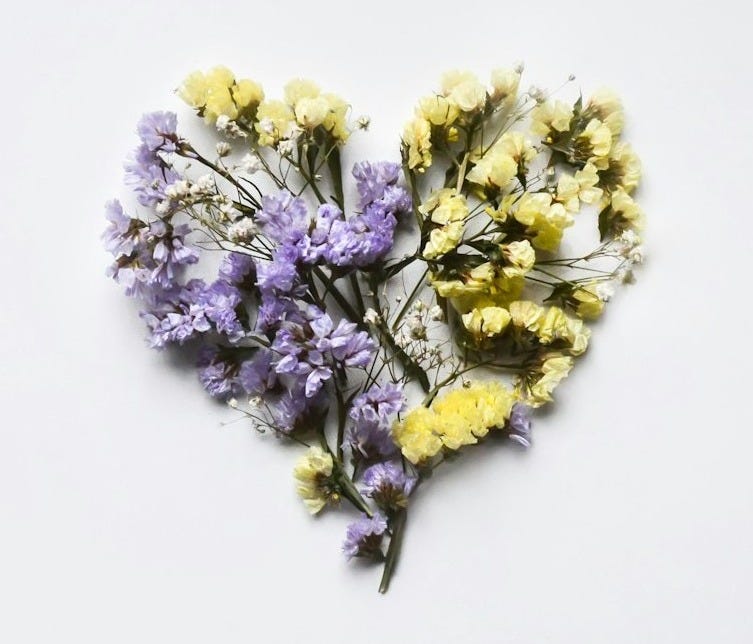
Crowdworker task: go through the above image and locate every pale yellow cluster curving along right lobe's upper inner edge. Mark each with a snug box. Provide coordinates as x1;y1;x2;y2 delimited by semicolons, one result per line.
402;69;520;172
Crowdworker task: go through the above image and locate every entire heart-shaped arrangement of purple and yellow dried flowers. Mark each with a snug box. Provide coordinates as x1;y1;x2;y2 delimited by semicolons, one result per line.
104;67;643;592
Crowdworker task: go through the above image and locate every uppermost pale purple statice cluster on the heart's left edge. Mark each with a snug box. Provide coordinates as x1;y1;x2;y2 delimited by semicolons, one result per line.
125;112;181;209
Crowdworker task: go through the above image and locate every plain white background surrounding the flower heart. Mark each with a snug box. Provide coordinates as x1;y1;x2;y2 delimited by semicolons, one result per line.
0;0;753;644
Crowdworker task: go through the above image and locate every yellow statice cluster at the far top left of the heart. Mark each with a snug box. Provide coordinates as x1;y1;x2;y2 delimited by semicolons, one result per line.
178;66;264;123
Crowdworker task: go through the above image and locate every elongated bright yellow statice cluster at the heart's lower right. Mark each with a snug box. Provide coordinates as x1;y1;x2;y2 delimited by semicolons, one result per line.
392;381;516;465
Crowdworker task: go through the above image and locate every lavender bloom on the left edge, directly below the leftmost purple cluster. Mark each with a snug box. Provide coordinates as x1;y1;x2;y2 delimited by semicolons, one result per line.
140;280;212;349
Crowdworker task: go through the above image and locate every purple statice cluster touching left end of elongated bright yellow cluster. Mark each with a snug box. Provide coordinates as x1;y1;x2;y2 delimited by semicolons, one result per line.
345;383;405;462
